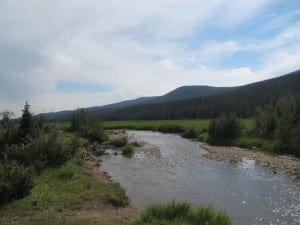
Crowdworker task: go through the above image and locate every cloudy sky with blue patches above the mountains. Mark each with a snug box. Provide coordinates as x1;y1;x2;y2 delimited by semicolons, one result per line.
0;0;300;115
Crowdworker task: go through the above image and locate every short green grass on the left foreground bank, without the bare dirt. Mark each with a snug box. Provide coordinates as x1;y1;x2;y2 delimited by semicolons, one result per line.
0;151;128;225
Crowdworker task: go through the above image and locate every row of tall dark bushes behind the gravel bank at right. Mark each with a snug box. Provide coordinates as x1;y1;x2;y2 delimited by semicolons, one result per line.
208;94;300;157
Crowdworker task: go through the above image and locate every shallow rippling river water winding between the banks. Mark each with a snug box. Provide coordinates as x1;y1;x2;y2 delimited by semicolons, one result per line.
101;131;300;225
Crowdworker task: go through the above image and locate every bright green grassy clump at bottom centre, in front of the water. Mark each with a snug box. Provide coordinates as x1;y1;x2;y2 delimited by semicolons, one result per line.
134;201;232;225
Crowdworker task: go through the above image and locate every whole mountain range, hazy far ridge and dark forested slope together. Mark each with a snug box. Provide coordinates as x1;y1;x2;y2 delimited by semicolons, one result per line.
44;70;300;120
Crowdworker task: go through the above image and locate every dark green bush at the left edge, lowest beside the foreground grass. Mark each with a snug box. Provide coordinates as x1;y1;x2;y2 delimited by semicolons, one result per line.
0;162;33;205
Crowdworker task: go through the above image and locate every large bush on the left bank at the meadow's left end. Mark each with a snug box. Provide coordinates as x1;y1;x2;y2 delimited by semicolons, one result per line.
70;109;107;142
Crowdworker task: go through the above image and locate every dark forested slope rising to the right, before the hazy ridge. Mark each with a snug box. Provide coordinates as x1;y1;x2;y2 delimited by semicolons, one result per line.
101;70;300;120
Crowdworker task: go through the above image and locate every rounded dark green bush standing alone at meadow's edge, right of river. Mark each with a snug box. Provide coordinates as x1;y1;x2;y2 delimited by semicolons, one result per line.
208;113;242;144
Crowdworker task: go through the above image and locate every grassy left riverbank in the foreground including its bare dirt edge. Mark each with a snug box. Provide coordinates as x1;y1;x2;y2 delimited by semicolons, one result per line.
0;148;138;225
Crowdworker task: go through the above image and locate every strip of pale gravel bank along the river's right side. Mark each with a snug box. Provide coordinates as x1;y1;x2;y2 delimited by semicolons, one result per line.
201;143;300;176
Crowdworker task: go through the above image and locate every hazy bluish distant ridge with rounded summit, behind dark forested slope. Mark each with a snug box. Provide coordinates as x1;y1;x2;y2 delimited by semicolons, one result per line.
42;86;234;121
